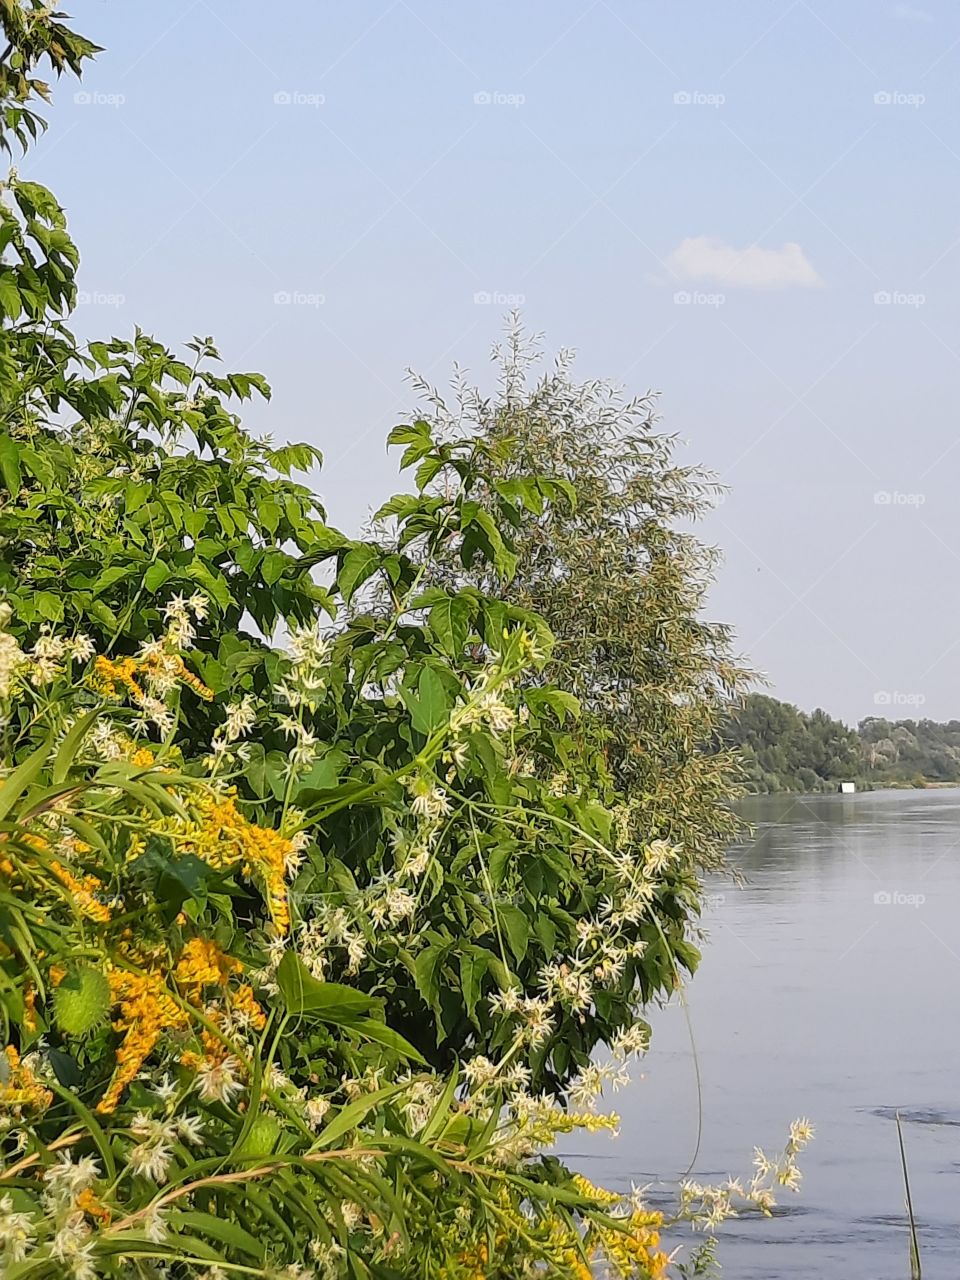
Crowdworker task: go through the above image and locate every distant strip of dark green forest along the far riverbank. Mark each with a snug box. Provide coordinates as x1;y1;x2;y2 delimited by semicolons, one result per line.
723;694;960;792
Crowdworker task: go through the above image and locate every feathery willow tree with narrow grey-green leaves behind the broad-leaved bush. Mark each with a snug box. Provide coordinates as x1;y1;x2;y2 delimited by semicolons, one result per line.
413;317;750;869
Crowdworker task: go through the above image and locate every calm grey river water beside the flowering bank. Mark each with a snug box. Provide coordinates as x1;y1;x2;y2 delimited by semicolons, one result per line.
566;788;960;1280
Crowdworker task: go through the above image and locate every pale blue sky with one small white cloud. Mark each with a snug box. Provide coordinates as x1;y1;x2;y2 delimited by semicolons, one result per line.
32;0;960;722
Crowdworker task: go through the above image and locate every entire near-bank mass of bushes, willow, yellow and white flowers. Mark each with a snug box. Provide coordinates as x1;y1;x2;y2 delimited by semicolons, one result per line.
0;0;810;1280
